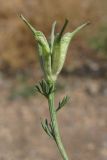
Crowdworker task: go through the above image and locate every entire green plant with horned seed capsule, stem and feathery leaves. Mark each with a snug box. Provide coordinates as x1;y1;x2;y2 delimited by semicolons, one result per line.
20;15;89;160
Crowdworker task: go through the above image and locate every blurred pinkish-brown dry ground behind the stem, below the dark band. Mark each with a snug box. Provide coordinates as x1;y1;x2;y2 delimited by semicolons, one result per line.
0;77;107;160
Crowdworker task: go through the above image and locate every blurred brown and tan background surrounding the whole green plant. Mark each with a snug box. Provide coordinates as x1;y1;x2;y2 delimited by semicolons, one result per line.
0;0;107;160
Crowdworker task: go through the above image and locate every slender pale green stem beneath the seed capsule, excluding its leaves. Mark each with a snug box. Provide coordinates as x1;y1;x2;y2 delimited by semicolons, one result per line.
48;83;68;160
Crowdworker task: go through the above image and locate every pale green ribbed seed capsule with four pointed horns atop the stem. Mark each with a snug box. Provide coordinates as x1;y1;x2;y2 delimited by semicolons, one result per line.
20;15;89;82
